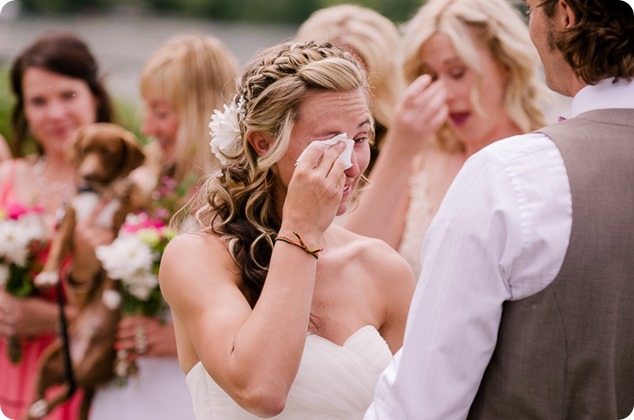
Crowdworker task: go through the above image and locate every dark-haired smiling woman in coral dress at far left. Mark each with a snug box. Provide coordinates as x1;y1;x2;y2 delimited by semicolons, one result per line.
0;32;113;420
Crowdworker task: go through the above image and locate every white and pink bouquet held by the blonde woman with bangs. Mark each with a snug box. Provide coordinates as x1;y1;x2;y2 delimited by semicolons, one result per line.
96;212;175;385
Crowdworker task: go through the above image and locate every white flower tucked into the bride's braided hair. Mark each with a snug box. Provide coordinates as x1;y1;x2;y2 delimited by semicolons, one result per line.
209;103;244;165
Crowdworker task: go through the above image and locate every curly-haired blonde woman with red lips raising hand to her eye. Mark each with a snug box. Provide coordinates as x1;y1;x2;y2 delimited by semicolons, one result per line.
346;0;549;277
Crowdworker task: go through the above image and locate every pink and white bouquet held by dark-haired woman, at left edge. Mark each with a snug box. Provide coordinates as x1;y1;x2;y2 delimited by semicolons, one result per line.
0;204;48;363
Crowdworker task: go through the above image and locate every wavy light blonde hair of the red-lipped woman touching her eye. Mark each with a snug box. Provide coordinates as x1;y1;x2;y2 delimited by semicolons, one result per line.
401;0;552;150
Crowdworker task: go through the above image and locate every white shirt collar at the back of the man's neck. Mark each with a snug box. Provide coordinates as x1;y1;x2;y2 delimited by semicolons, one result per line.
570;77;634;117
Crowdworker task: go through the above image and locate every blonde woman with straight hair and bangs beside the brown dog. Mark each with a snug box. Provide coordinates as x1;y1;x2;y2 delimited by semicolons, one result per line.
85;35;238;420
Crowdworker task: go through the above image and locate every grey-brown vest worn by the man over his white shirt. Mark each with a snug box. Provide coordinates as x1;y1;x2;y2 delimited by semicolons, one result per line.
468;109;634;420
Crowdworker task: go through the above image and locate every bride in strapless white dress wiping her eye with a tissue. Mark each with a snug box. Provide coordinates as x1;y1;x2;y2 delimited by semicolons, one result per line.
159;42;414;420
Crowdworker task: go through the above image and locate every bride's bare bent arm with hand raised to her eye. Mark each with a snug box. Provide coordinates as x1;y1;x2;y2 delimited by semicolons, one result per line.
159;145;345;416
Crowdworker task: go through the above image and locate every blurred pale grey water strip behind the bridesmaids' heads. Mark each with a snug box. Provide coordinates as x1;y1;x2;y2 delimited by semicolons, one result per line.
0;11;297;104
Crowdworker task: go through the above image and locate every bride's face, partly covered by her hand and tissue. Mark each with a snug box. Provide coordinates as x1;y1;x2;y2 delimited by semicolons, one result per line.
277;88;372;214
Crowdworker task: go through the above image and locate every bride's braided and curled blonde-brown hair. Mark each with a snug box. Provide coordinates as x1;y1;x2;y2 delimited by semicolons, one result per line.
196;42;369;306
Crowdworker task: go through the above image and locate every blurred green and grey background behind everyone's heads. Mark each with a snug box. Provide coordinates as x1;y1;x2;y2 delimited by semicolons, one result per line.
0;0;523;142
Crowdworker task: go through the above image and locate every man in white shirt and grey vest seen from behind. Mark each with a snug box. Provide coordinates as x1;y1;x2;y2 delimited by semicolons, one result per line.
366;0;634;420
